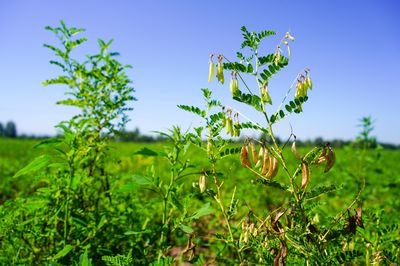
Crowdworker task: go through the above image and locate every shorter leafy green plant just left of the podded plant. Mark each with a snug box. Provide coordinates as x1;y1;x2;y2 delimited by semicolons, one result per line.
130;126;214;265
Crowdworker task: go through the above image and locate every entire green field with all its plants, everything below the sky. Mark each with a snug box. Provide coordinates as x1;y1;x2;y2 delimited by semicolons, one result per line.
0;21;400;266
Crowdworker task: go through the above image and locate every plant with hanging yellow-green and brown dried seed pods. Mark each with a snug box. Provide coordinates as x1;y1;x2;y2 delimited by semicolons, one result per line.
179;27;363;265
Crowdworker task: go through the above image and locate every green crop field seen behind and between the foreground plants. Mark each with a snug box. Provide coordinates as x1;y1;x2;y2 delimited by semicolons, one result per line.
0;139;400;264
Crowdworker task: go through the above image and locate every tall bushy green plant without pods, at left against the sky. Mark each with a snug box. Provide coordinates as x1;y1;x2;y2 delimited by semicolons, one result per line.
0;21;135;265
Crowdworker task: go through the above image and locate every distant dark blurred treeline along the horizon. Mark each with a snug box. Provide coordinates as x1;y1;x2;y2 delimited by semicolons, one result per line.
0;121;400;150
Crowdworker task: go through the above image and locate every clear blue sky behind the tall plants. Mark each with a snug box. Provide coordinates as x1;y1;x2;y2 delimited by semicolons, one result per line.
0;0;400;144
